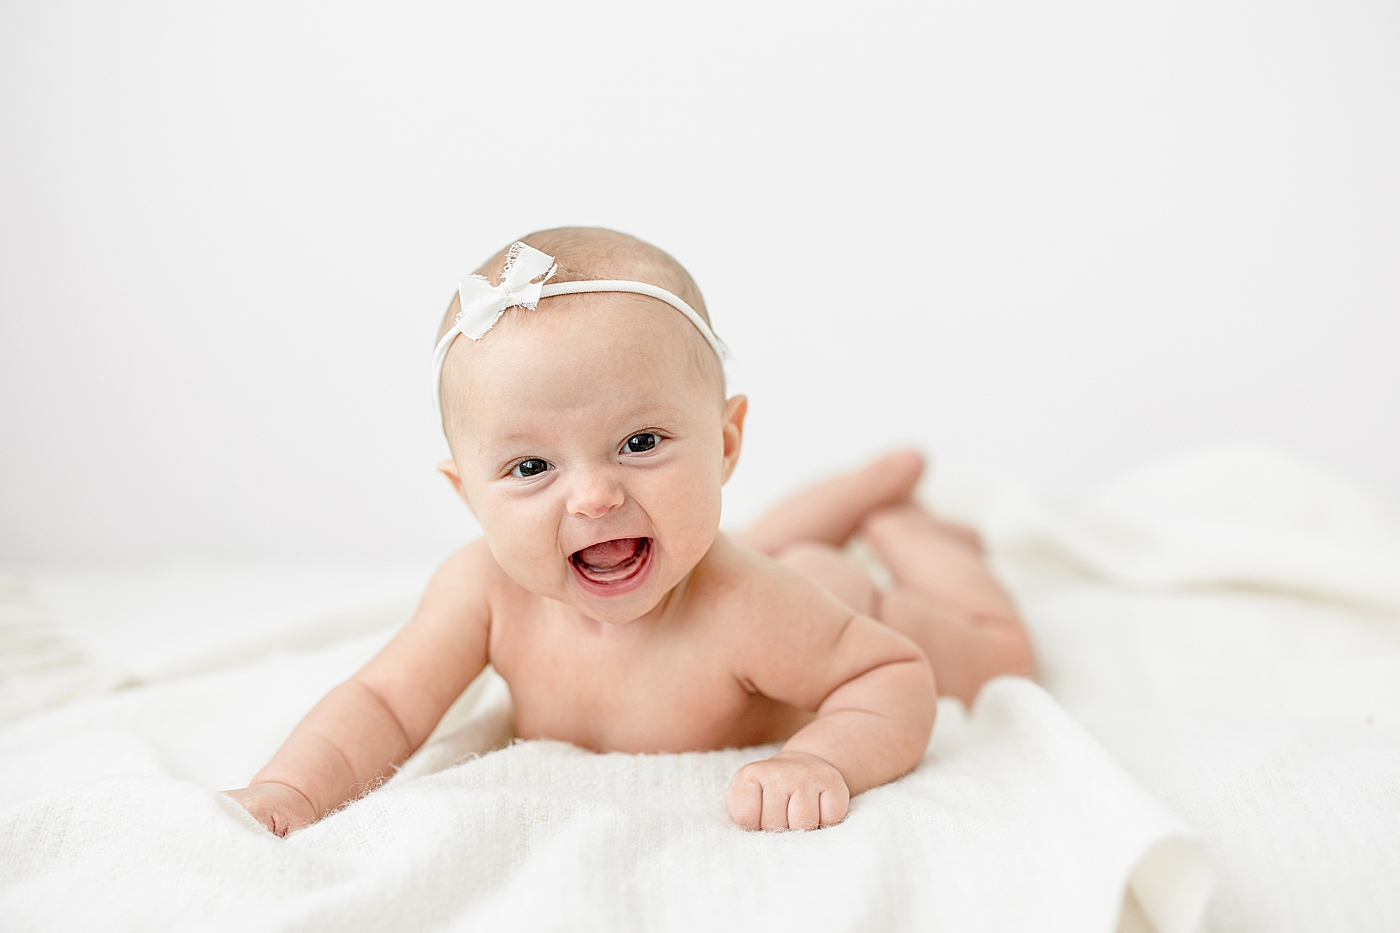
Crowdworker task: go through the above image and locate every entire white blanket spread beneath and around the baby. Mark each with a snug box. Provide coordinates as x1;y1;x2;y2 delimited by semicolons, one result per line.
0;448;1400;932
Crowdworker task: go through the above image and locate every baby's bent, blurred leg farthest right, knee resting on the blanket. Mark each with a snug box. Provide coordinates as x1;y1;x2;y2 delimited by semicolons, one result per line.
861;503;1035;703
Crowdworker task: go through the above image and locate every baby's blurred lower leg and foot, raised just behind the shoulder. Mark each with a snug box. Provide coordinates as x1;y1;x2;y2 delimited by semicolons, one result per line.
736;450;924;556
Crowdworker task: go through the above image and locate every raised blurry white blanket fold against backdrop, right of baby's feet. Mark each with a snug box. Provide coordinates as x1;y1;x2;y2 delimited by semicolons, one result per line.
957;443;1400;611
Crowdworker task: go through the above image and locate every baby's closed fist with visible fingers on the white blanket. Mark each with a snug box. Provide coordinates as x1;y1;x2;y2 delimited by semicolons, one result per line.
724;751;851;829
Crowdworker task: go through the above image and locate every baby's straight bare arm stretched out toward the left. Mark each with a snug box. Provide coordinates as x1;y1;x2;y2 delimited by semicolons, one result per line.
228;542;490;836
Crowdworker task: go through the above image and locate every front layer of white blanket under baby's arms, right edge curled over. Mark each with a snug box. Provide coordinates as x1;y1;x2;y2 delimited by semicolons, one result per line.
0;657;1205;932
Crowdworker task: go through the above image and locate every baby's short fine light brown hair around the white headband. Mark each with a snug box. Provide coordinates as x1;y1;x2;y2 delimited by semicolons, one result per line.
437;227;725;417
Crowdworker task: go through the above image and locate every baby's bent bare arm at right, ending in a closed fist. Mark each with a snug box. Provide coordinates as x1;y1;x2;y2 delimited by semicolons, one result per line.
725;565;937;829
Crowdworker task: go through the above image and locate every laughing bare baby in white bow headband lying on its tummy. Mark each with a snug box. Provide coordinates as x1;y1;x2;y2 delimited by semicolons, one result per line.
230;228;1030;835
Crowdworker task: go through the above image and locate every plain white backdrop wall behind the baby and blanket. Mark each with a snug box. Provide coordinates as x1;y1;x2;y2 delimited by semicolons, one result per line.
0;0;1400;563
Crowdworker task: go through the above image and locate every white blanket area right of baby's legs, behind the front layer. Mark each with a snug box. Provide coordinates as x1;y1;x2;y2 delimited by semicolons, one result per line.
930;444;1400;933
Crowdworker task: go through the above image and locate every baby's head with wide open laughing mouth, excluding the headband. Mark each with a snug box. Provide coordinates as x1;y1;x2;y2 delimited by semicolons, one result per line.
438;227;746;623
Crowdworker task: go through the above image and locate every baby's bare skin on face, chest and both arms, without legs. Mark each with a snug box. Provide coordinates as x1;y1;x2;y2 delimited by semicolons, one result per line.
230;226;935;835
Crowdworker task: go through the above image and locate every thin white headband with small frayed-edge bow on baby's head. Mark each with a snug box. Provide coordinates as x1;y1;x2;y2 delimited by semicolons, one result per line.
433;241;729;412
